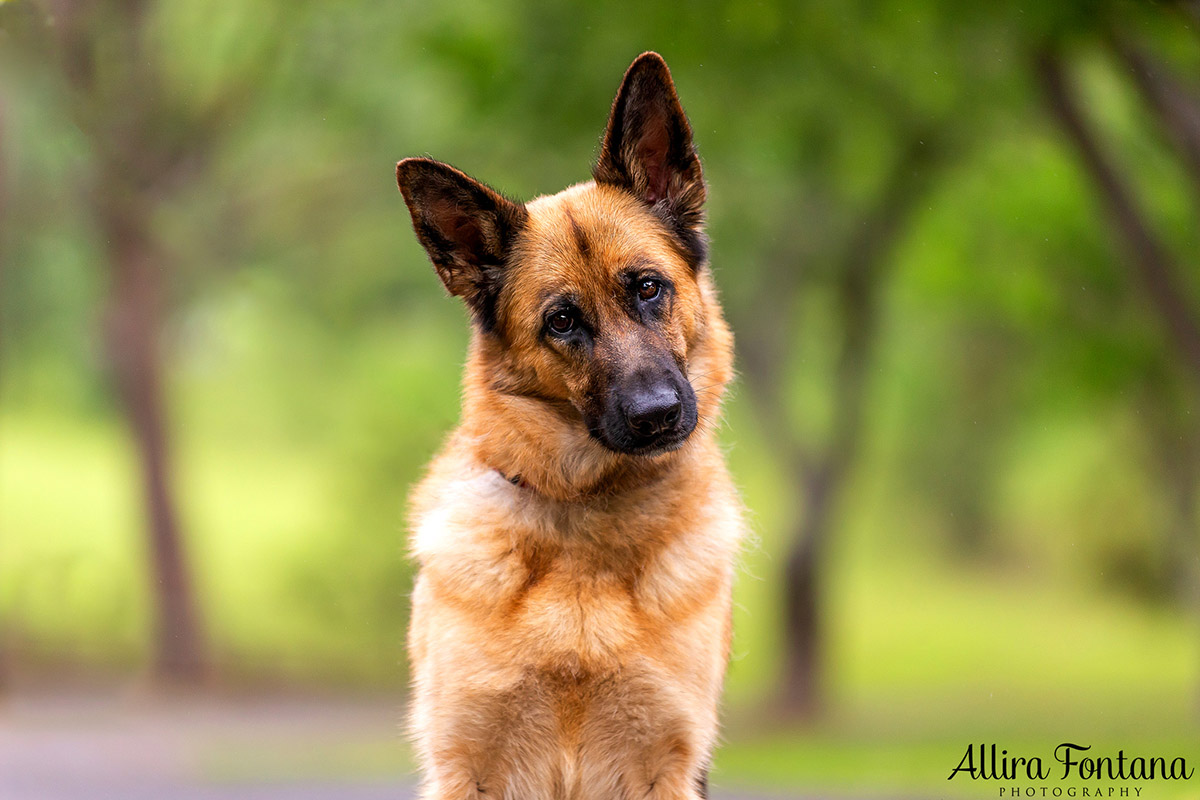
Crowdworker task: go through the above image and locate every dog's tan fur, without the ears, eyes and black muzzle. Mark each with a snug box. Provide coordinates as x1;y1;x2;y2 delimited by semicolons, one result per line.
409;53;743;800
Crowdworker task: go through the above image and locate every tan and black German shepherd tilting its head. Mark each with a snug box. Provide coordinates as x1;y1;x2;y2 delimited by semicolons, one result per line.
396;53;743;800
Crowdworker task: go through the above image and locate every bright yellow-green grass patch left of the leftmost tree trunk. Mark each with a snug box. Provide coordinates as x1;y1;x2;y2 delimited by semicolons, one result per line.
0;416;148;666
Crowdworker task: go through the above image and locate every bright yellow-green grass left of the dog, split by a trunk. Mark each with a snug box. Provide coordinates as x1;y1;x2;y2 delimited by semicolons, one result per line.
0;415;403;684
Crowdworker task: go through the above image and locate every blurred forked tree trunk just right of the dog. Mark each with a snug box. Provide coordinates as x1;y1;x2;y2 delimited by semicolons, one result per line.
742;131;943;718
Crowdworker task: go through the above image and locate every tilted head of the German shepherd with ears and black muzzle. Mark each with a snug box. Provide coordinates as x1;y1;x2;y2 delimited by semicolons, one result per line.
396;53;727;456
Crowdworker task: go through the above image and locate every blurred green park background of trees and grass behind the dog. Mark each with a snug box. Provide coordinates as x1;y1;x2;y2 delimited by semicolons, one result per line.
0;0;1200;796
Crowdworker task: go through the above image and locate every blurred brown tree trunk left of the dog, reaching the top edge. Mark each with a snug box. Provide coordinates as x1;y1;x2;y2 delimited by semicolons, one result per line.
38;0;210;685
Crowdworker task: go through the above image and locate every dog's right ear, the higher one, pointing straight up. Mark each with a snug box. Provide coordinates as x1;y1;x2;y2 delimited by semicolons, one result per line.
592;53;706;265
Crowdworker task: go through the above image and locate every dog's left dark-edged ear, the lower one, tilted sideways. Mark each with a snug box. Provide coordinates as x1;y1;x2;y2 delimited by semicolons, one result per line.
396;158;527;330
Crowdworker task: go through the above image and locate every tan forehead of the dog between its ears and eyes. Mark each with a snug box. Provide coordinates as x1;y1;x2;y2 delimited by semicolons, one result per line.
511;182;689;297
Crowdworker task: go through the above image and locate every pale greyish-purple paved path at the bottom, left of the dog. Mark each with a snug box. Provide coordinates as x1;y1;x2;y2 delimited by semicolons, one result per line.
0;693;816;800
